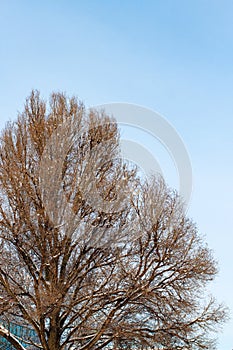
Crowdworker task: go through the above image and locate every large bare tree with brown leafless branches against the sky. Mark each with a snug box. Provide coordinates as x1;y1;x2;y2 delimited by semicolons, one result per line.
0;91;226;350
